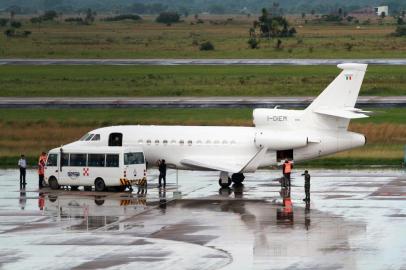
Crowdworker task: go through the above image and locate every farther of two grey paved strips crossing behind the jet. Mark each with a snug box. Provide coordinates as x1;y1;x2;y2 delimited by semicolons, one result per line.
0;58;406;66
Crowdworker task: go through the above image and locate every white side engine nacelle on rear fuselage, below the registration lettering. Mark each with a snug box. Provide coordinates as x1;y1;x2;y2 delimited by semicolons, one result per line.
255;130;309;150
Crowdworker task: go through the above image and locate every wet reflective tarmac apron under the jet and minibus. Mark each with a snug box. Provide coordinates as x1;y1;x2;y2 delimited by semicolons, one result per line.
0;169;406;269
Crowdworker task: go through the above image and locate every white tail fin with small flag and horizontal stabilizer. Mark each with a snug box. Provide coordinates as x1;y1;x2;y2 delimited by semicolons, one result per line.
305;63;368;129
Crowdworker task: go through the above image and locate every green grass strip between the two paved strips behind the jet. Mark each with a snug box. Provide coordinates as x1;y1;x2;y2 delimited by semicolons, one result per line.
0;66;406;97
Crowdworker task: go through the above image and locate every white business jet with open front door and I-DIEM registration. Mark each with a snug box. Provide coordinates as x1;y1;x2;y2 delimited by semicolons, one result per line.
66;63;368;186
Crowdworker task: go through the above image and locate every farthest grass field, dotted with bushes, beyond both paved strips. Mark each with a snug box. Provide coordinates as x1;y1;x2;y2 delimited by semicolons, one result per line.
0;15;406;58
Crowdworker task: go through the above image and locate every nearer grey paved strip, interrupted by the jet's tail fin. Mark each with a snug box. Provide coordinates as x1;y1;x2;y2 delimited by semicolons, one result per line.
0;96;406;108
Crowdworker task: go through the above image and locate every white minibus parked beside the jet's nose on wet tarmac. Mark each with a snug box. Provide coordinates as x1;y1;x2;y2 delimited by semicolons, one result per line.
45;146;146;191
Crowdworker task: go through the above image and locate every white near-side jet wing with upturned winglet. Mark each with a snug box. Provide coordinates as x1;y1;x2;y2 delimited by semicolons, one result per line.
180;148;267;173
